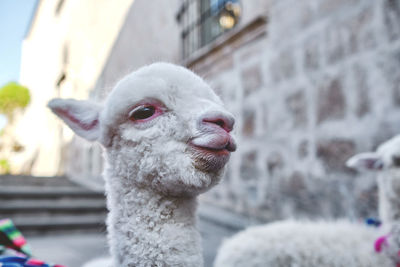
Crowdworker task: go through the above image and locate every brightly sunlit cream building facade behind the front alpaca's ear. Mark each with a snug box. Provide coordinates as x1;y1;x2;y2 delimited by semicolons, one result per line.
18;0;132;179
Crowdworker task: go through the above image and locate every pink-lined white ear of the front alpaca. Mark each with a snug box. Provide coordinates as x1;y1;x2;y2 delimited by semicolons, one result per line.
47;99;101;141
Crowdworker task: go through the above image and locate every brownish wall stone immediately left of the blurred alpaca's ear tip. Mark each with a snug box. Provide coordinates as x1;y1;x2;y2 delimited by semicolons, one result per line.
317;139;356;172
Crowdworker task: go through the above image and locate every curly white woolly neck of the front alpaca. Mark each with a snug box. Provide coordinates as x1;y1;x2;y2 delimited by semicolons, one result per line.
106;177;203;267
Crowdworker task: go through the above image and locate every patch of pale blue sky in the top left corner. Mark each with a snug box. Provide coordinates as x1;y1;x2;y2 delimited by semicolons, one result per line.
0;0;37;87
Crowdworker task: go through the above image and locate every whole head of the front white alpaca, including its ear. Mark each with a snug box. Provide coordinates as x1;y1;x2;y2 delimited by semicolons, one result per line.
49;63;236;196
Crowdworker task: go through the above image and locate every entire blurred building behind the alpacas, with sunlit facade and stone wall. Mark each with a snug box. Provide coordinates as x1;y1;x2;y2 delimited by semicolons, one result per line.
15;0;400;224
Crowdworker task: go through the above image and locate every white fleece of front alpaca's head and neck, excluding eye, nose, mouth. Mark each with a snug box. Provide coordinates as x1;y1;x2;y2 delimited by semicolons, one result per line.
49;63;238;267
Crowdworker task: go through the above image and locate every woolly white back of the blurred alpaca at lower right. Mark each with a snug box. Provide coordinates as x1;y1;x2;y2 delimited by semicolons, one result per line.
215;221;395;267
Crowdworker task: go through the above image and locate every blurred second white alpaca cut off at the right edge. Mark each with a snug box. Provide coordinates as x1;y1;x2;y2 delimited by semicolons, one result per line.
215;136;400;267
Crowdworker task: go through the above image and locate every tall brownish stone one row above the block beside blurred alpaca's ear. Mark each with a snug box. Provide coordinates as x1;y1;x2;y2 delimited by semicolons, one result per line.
317;77;346;123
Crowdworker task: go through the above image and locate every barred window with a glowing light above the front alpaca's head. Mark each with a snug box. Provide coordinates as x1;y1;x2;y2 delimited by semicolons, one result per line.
177;0;241;58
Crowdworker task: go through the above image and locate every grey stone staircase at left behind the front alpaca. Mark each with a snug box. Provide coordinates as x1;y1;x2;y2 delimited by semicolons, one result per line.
0;176;107;235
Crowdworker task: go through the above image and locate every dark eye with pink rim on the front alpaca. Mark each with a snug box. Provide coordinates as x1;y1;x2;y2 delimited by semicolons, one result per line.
128;100;166;123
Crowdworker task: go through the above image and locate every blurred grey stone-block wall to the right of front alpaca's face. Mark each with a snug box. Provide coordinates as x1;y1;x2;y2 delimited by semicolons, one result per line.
188;0;400;221
